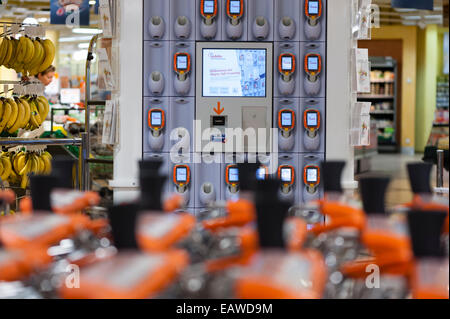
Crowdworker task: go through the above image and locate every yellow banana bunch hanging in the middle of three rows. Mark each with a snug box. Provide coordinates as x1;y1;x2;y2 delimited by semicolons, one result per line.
0;96;50;134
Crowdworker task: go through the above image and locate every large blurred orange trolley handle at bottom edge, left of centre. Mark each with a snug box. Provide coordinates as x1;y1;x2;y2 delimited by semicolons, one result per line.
59;250;189;299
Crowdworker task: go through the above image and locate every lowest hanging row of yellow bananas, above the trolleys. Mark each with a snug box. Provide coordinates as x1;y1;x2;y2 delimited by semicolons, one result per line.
0;151;52;189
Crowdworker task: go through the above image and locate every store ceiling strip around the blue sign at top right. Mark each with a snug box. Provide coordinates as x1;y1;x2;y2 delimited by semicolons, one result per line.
372;0;449;27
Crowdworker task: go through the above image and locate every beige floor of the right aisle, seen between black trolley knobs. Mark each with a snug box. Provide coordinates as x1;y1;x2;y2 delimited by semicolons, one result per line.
357;154;449;207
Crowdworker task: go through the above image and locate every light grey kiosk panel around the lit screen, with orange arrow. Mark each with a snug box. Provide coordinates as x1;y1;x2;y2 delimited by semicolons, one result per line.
194;41;276;153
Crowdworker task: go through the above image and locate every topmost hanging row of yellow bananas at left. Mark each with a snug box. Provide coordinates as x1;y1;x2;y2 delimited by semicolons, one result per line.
0;35;56;76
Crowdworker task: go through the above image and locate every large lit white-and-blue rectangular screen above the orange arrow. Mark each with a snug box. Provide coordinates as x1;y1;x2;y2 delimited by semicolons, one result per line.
203;49;267;97
